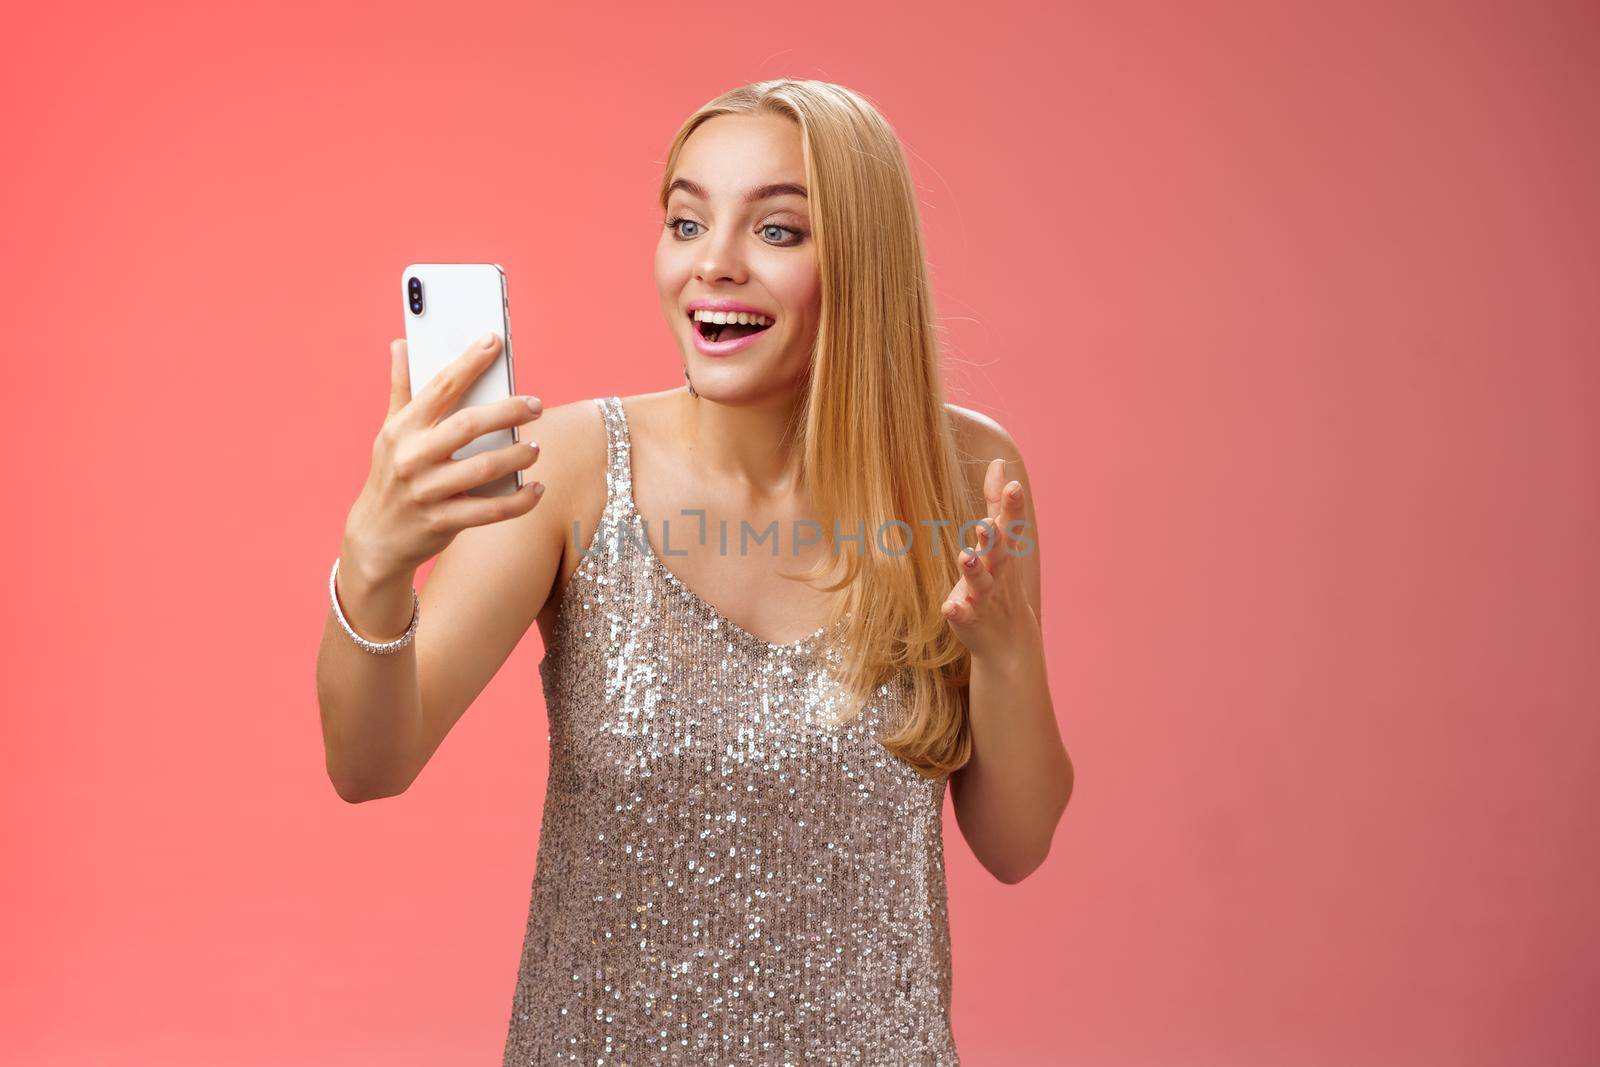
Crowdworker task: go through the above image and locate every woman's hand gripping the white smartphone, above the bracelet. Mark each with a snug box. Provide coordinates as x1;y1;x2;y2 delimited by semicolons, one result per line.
344;333;544;576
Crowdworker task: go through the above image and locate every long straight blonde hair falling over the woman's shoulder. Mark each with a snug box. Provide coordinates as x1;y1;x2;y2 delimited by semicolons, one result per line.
661;78;986;777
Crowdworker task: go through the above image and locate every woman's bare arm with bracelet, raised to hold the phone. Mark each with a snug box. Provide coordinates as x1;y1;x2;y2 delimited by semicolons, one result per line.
317;346;605;803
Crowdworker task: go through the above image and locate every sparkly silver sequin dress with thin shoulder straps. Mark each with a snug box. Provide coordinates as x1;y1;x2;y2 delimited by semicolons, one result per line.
504;397;960;1067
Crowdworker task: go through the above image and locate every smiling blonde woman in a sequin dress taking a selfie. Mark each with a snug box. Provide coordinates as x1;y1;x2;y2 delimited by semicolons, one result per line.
317;78;1074;1065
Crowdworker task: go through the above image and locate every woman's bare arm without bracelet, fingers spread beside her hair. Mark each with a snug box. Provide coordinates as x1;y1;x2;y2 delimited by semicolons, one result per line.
946;408;1074;883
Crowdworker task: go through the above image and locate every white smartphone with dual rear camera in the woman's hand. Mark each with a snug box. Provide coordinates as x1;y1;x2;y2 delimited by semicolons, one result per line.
400;262;523;496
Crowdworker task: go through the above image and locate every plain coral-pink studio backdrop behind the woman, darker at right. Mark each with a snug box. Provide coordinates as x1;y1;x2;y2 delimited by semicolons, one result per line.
0;2;1600;1067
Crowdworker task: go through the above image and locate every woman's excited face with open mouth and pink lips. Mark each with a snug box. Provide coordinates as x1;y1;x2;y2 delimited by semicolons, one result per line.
656;114;821;402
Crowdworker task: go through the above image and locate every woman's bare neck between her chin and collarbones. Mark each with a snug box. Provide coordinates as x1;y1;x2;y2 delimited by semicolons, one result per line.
677;390;802;498
